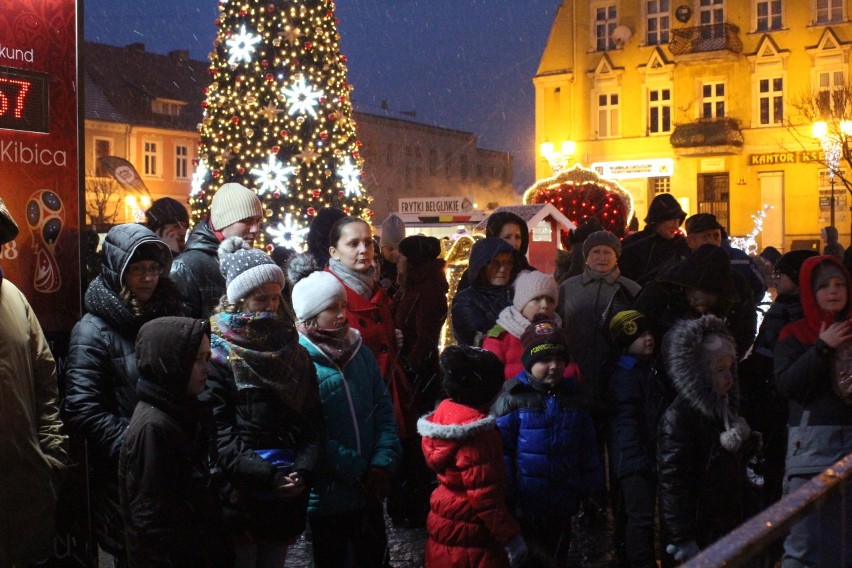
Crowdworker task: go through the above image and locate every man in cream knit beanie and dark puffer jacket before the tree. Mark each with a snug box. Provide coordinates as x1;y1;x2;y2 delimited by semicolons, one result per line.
171;183;263;319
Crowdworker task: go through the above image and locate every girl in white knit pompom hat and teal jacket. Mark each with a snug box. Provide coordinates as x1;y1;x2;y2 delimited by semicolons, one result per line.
287;254;402;568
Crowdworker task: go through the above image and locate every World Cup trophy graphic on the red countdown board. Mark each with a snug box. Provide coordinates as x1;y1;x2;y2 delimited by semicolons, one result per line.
27;189;65;294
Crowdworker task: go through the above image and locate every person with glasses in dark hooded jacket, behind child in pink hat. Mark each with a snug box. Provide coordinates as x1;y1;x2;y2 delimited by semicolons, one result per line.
450;237;517;346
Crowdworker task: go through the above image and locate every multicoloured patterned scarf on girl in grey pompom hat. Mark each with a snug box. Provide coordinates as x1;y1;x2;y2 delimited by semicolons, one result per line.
210;312;313;412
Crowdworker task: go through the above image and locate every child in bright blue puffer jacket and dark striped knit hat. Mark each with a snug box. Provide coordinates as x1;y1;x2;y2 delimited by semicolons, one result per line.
491;315;604;563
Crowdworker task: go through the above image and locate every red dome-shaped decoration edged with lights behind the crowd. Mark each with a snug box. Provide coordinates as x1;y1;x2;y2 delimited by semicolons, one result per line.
524;165;633;237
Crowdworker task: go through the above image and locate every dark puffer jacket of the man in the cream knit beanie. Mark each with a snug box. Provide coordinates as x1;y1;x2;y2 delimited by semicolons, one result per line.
171;221;225;319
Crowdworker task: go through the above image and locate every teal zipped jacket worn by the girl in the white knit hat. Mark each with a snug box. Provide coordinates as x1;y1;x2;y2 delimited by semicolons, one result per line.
299;329;402;516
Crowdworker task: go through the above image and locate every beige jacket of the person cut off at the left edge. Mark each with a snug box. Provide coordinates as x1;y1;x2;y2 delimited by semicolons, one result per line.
0;272;68;566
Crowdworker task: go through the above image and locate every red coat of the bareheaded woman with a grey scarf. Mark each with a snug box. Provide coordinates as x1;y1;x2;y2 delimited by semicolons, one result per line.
326;268;417;440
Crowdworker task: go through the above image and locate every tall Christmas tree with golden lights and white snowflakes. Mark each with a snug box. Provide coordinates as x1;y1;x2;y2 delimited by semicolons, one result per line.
190;0;372;249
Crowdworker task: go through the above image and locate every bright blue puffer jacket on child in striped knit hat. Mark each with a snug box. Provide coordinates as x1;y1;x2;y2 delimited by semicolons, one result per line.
491;371;604;518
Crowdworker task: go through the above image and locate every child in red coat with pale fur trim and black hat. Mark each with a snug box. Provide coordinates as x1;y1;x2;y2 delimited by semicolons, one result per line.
417;346;527;568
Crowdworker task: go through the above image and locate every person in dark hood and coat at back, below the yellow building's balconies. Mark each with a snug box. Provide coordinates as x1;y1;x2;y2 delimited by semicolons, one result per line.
618;193;689;286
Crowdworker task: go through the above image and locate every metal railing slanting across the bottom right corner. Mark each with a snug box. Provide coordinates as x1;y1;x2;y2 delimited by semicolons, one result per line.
684;454;852;568
